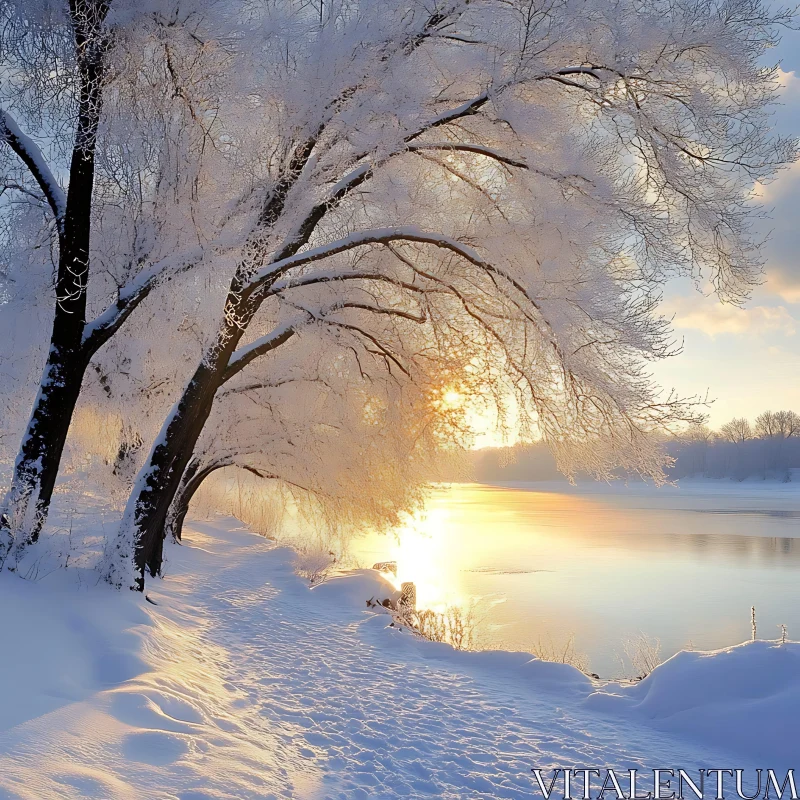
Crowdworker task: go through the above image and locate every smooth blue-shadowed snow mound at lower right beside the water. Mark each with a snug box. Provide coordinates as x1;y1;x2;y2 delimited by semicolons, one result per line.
585;641;800;766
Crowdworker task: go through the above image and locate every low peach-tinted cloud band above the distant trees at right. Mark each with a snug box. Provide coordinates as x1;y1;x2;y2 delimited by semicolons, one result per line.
664;295;800;337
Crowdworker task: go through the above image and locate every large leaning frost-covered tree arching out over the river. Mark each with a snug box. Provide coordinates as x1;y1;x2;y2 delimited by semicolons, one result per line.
92;0;795;588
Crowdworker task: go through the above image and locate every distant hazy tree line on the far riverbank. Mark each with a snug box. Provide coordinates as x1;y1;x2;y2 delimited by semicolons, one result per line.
473;411;800;483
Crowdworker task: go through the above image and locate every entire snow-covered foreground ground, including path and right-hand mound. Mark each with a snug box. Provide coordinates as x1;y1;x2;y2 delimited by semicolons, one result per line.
0;520;800;800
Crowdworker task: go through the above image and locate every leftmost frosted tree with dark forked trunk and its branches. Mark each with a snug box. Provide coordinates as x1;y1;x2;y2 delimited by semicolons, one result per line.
0;0;264;566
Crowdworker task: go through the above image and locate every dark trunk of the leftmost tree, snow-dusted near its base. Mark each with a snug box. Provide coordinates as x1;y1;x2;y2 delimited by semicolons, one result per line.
0;0;108;567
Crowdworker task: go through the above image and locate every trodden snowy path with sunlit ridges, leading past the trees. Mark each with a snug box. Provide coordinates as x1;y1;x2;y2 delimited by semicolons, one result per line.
0;524;792;800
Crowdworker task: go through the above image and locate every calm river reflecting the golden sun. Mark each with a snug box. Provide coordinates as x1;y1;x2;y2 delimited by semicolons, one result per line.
353;482;800;677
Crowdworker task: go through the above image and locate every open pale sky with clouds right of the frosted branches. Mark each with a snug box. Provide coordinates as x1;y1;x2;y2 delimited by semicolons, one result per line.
653;23;800;427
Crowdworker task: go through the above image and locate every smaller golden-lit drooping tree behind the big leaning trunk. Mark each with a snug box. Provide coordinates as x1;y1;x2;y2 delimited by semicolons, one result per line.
162;337;464;562
